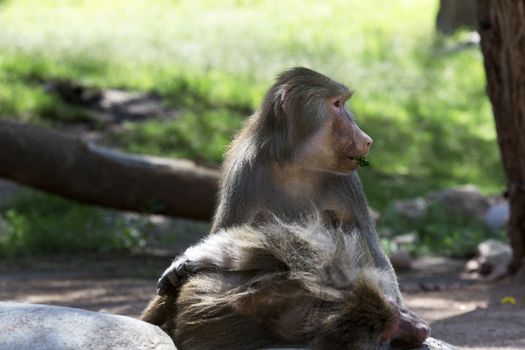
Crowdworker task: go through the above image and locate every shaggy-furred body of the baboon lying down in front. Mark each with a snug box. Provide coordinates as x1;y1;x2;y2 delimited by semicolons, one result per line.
142;214;401;350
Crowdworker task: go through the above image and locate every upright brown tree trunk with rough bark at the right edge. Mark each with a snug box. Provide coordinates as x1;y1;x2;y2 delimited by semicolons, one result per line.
478;0;525;272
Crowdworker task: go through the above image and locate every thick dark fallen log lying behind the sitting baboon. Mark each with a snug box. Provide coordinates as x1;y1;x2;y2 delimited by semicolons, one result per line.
0;119;218;220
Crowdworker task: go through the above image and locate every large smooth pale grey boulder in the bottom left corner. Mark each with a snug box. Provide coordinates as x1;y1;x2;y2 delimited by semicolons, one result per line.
0;302;176;350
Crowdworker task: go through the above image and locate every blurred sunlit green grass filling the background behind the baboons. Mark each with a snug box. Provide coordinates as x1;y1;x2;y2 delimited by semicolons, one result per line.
0;0;505;256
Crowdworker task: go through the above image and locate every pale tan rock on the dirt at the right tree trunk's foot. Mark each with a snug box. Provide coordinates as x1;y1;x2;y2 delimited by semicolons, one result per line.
478;239;512;275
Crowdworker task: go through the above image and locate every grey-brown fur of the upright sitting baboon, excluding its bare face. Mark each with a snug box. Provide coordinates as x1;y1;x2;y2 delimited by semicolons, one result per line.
211;68;403;304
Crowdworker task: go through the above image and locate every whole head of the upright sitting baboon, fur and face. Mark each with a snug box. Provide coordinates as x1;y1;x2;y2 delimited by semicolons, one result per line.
256;68;373;173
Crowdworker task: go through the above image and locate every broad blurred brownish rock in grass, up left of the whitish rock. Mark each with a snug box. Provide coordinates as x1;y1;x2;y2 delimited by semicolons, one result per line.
428;185;491;221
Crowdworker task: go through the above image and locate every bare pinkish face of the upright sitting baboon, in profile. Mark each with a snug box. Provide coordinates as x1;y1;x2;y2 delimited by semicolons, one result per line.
297;92;373;174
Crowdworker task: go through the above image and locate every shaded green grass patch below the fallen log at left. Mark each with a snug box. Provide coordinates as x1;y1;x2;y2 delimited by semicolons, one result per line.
0;191;144;257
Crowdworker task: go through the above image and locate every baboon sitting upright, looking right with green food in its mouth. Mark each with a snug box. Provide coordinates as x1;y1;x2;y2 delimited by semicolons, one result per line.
158;68;429;346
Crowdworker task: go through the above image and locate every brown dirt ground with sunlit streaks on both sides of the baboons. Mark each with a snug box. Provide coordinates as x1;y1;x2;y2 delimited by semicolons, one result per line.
0;253;525;350
